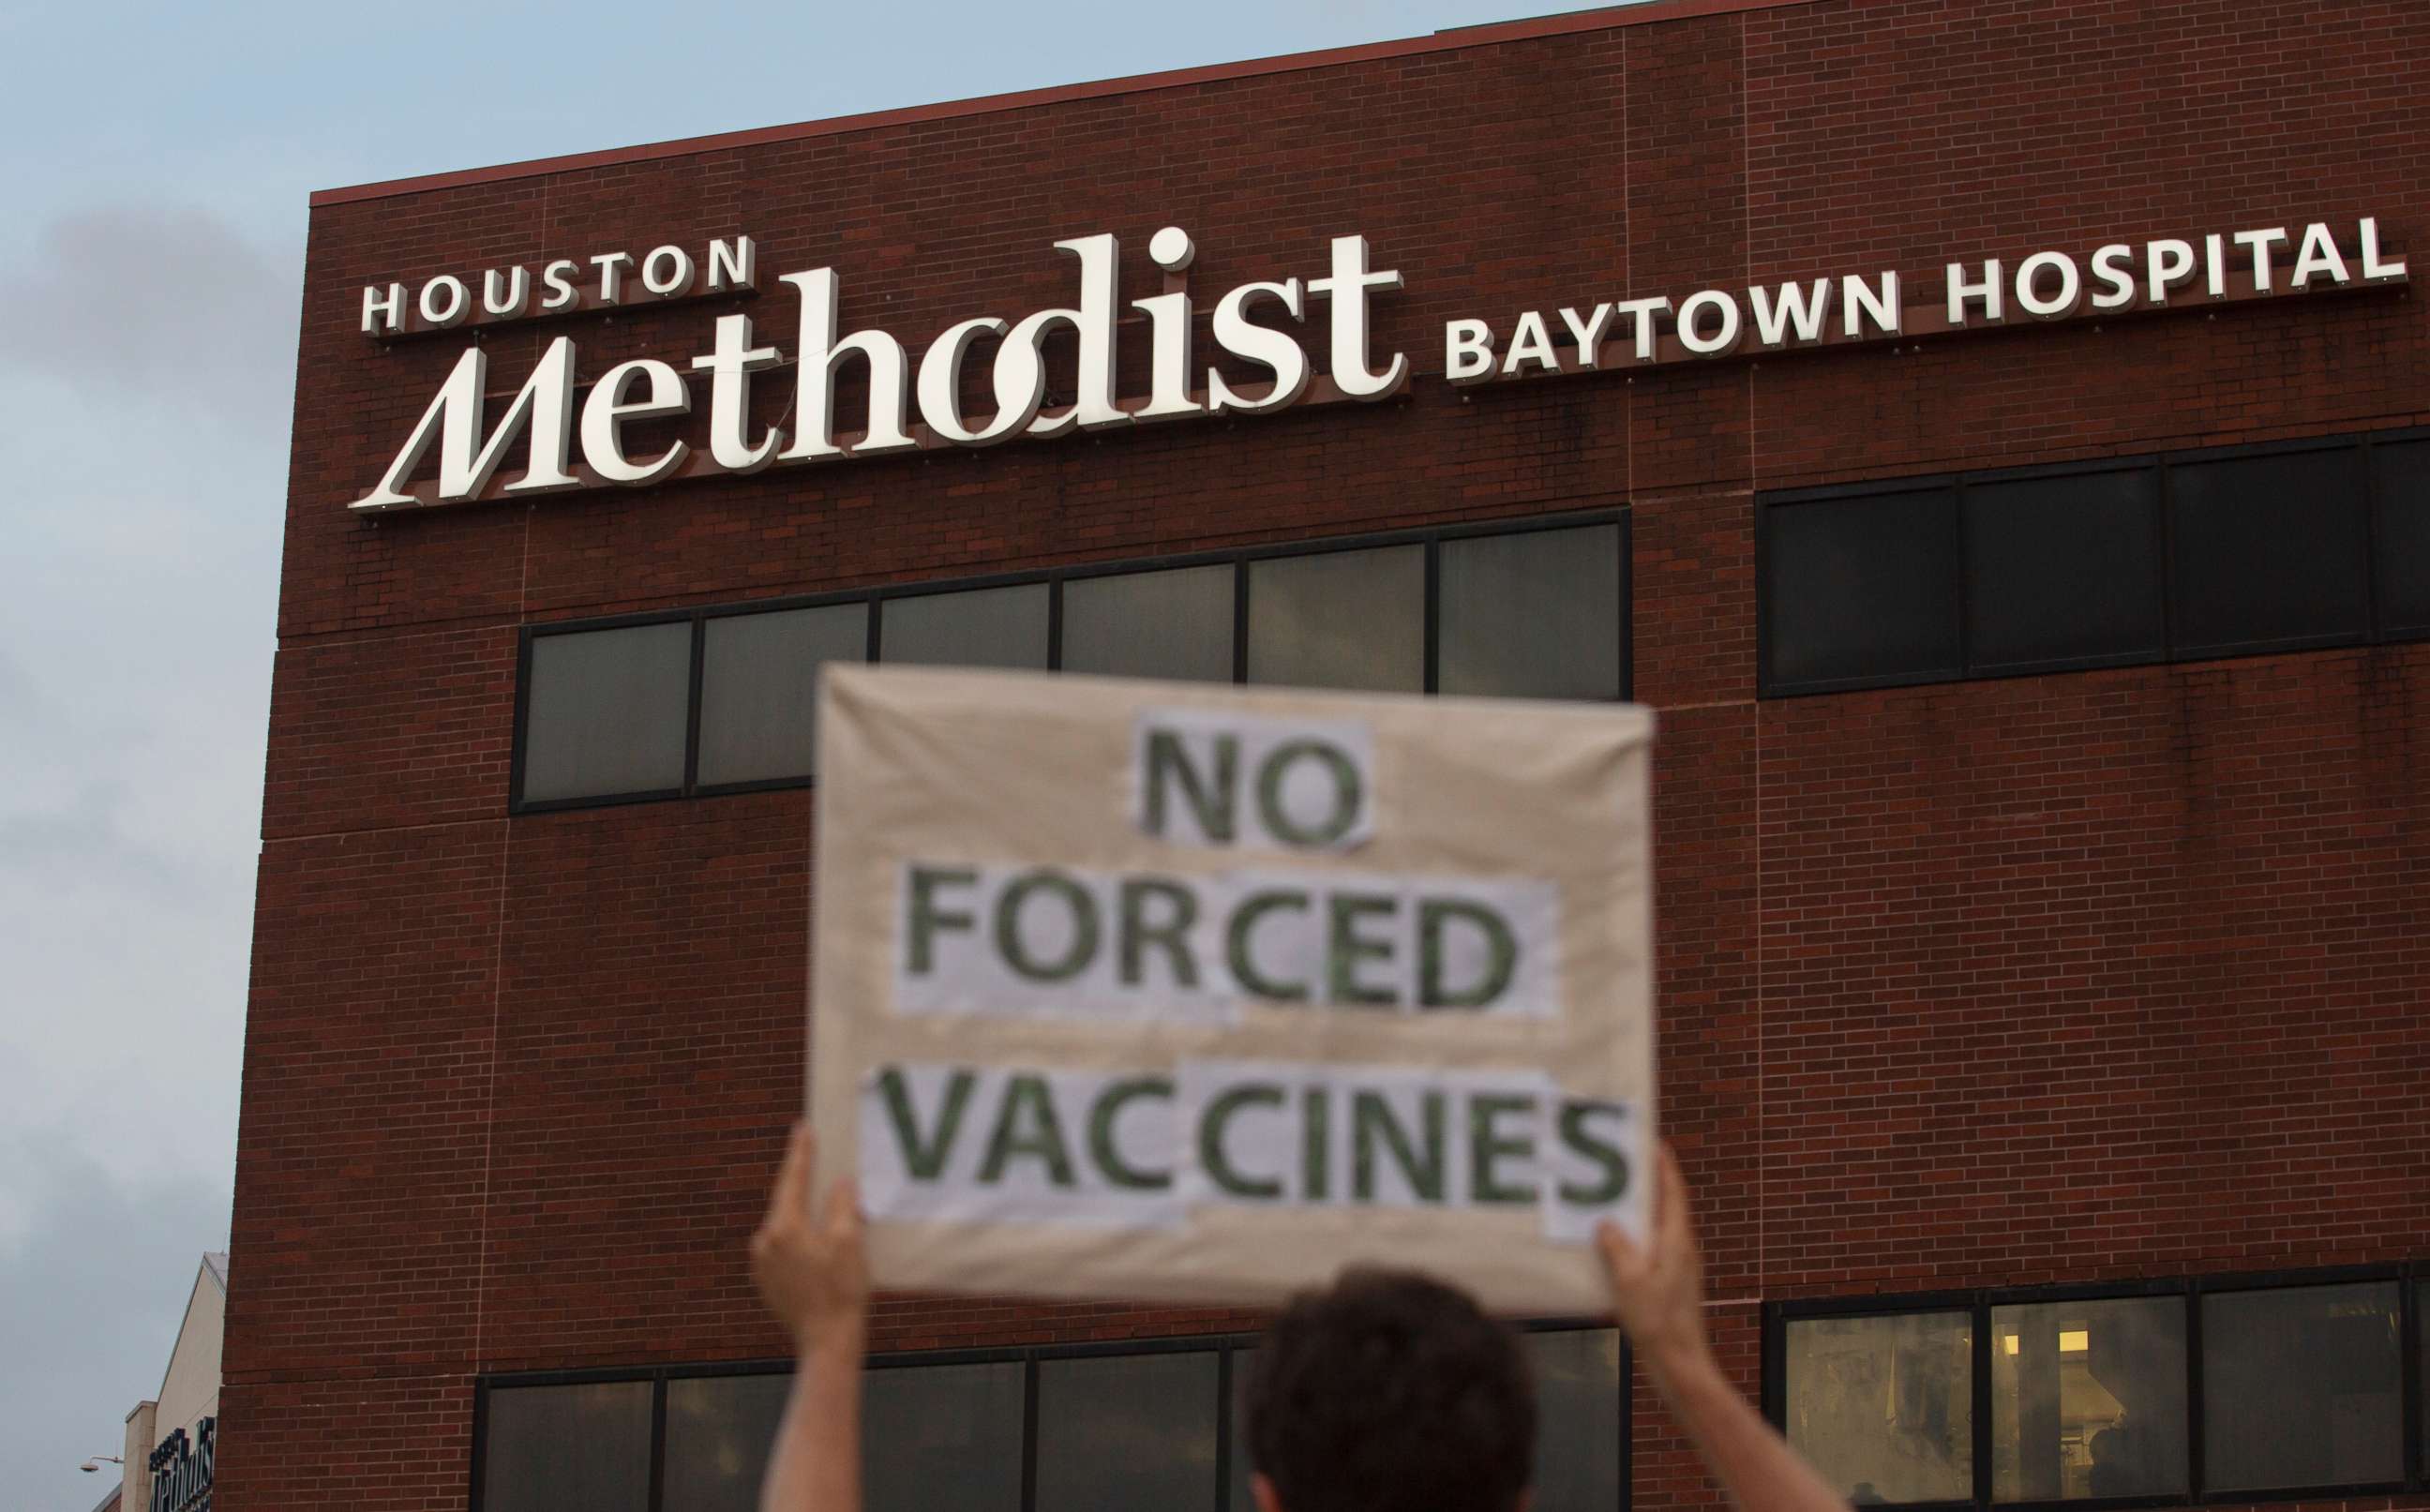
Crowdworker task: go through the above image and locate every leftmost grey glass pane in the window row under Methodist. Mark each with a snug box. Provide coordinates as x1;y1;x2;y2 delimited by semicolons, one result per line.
522;622;693;802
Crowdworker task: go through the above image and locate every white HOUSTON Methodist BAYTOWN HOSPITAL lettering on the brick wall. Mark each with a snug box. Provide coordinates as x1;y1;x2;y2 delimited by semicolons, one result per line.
352;218;2408;511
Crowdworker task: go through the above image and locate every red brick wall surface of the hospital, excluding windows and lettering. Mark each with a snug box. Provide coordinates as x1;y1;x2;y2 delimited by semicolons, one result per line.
218;0;2430;1512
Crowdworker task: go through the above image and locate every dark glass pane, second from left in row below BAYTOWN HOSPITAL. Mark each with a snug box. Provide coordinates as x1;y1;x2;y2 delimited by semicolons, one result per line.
1966;467;2165;668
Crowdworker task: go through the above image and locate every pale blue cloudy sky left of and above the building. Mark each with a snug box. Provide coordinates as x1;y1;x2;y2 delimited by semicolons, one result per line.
0;0;1652;1512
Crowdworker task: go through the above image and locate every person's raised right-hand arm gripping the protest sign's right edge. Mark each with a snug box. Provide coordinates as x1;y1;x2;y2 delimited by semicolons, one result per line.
1594;1145;1847;1512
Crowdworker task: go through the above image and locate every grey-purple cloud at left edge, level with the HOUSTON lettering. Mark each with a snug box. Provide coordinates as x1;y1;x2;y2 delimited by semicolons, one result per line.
0;206;299;427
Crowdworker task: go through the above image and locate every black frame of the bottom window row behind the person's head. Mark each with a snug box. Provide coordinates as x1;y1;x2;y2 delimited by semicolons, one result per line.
467;1318;1635;1512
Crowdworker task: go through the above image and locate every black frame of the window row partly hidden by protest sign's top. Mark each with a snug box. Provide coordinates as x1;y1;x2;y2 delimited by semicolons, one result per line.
505;505;1635;816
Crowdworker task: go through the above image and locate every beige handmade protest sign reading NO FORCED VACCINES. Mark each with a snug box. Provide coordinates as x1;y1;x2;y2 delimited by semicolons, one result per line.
809;666;1653;1312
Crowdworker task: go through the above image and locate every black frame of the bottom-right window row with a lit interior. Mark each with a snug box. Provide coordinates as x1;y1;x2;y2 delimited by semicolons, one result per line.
1762;1259;2430;1512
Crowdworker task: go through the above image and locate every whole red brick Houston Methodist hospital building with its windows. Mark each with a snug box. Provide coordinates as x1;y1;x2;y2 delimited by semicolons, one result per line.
236;0;2430;1512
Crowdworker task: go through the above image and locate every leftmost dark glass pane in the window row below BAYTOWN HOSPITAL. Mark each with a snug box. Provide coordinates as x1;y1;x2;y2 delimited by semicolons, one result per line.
1764;488;1958;685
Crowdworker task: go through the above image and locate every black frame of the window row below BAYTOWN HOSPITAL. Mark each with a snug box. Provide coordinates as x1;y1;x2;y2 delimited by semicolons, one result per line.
1754;426;2430;697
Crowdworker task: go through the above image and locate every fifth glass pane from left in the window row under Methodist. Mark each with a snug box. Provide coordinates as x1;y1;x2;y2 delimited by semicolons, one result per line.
1249;546;1427;693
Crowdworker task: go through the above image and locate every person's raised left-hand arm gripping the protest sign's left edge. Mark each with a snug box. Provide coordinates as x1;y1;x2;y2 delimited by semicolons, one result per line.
751;1123;870;1512
